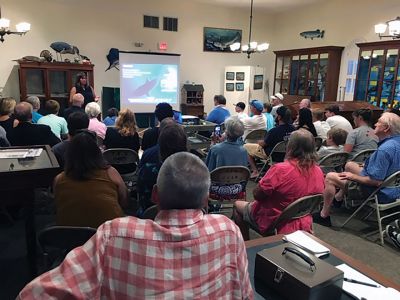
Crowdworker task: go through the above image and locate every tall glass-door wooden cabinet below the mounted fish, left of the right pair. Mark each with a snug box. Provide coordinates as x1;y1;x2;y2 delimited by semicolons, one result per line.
274;46;344;101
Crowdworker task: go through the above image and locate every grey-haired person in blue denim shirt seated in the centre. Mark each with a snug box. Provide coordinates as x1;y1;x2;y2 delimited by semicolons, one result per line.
206;117;247;171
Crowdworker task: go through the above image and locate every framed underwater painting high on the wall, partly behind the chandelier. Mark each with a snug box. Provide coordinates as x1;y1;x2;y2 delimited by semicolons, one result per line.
203;27;242;52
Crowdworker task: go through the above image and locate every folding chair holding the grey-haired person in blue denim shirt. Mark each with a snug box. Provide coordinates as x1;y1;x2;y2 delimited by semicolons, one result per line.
209;166;250;212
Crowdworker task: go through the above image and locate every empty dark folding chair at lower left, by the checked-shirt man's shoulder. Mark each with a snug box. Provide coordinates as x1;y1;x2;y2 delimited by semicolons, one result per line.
38;226;96;271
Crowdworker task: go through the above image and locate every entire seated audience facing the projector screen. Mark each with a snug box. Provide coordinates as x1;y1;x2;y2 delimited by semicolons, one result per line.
0;93;400;299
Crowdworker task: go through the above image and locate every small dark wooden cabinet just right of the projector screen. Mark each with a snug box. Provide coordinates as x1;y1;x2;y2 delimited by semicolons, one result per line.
181;84;204;118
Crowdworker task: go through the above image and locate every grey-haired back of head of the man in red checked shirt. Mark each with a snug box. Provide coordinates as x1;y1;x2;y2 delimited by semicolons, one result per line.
157;152;210;209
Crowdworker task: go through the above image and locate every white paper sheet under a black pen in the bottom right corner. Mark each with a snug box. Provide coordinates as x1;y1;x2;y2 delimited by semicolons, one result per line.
336;264;400;300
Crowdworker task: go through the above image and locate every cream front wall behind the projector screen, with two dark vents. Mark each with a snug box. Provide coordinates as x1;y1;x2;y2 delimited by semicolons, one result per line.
0;0;273;111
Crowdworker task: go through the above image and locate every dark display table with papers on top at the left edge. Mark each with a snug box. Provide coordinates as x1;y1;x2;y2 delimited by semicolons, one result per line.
0;145;60;276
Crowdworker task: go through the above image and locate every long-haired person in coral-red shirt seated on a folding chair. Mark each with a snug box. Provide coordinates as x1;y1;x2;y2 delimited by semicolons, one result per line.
234;129;324;240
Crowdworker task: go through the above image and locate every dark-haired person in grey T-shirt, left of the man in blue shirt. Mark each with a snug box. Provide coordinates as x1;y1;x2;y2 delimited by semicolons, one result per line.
343;109;378;158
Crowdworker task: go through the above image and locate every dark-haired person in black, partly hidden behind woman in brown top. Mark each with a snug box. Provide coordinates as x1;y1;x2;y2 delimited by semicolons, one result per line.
51;111;89;170
